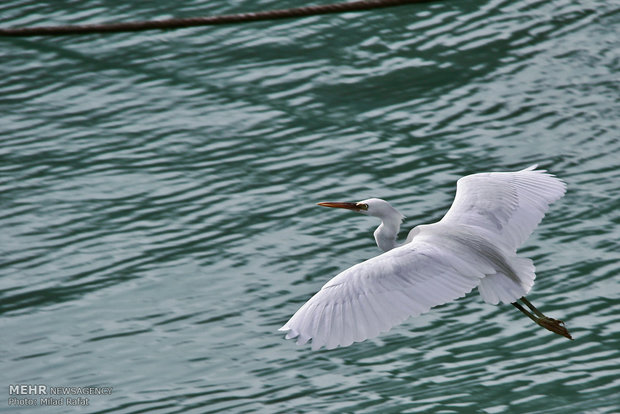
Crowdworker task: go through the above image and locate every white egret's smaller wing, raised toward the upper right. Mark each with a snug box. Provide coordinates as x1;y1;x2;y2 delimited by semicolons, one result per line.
440;165;566;252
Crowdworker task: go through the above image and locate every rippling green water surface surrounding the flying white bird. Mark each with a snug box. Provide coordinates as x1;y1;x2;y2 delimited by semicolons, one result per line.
0;0;620;414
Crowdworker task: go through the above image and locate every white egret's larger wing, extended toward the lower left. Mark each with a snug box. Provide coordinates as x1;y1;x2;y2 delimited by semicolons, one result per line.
280;232;494;349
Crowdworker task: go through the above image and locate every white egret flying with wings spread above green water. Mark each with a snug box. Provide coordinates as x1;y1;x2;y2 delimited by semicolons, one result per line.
280;165;572;349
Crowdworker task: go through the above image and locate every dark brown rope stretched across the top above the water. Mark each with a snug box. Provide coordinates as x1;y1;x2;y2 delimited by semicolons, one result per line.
0;0;434;36
